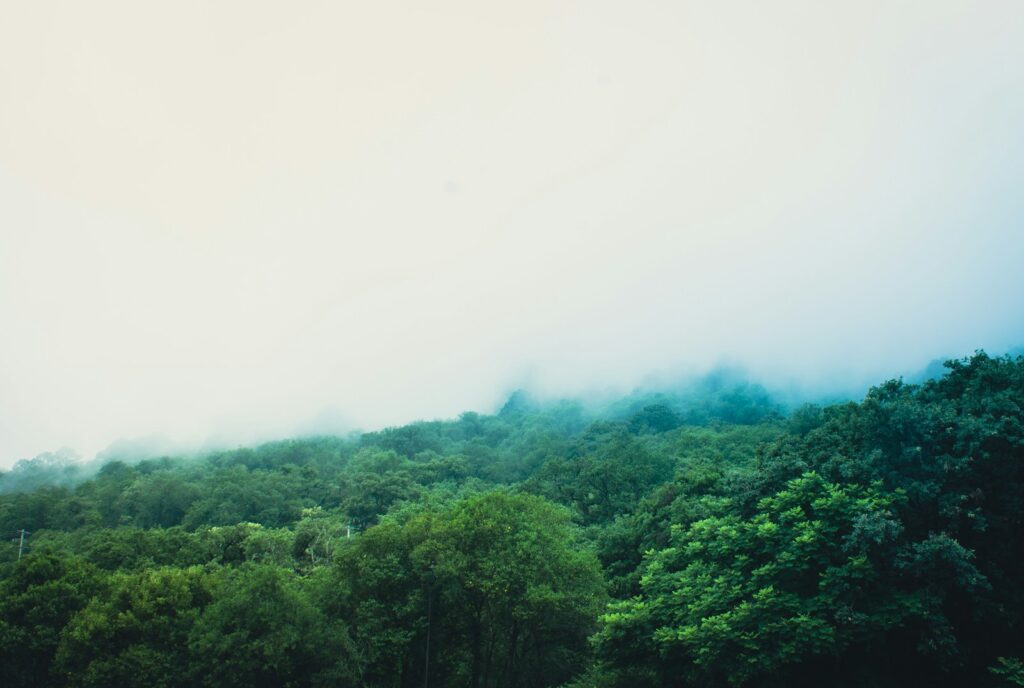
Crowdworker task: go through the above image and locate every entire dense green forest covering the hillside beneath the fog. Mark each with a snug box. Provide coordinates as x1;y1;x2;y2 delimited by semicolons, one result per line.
0;353;1024;688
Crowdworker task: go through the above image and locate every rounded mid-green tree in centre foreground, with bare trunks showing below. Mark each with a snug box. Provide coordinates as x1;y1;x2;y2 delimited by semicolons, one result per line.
330;491;603;686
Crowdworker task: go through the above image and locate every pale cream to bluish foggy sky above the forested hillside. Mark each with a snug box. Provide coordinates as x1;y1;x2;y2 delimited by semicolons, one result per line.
0;0;1024;467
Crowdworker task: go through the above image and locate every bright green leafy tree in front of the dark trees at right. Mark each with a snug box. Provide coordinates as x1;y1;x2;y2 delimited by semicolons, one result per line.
596;473;937;687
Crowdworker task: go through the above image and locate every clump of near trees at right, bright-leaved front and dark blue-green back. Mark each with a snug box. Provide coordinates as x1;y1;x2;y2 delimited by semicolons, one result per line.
596;354;1024;686
